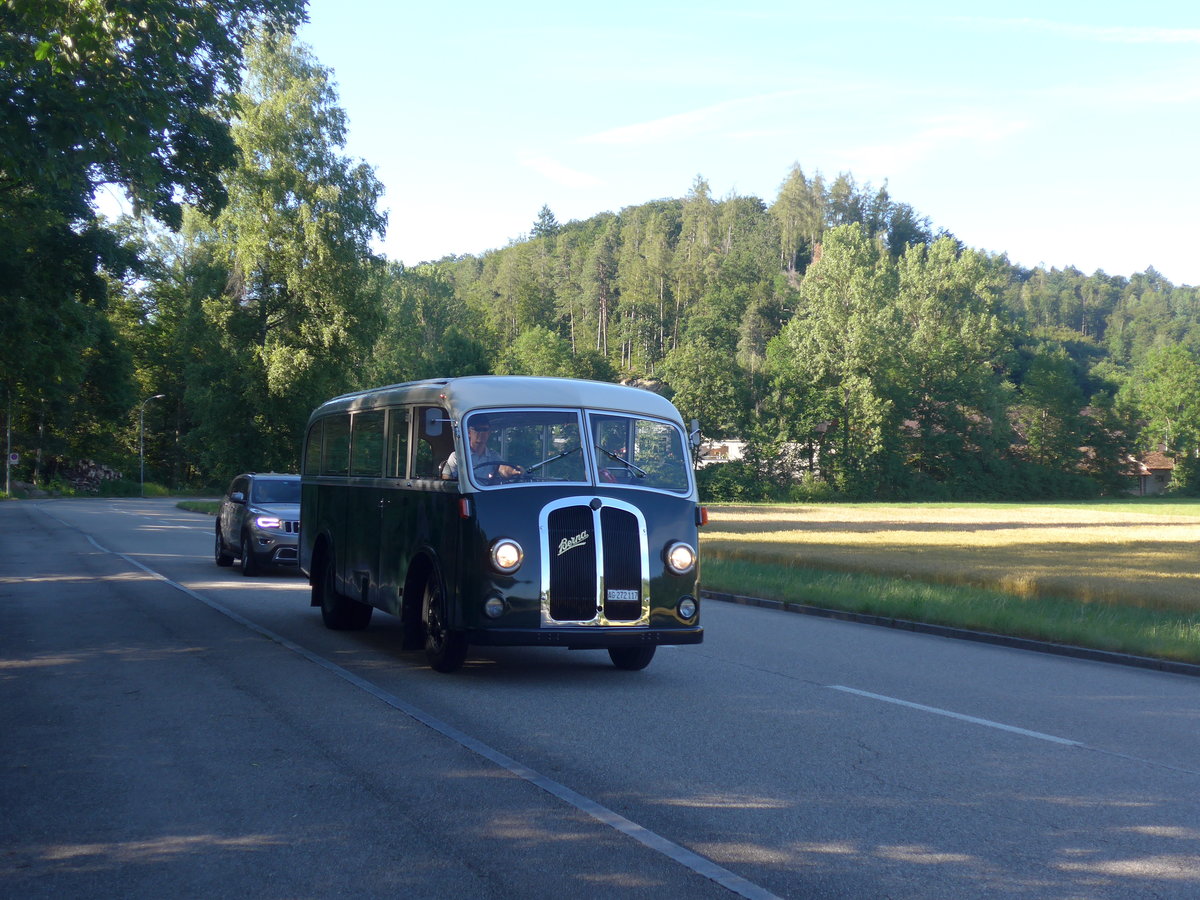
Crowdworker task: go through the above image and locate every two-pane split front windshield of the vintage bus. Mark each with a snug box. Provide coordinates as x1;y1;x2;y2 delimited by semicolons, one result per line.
463;409;690;493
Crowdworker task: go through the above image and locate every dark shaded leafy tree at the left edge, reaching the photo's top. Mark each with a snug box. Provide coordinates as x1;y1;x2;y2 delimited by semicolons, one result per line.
0;0;304;487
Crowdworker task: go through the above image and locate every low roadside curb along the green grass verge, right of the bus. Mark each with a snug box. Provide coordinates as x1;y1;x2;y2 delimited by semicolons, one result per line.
700;590;1200;678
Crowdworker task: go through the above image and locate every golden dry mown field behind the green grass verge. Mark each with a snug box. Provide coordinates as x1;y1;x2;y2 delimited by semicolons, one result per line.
701;504;1200;612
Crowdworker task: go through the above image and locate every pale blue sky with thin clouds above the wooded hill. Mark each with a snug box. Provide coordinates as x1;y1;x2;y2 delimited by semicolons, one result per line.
292;0;1200;286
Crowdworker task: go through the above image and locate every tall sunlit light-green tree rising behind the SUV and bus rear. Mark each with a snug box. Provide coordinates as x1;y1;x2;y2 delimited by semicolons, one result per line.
180;34;386;487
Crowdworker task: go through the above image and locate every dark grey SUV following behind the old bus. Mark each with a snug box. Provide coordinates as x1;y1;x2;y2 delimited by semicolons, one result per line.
215;473;300;575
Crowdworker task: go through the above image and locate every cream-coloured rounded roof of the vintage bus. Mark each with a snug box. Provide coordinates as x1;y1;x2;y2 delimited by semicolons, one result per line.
312;376;682;424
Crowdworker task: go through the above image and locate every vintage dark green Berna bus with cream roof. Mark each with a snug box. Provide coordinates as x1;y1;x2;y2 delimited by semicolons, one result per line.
300;376;706;672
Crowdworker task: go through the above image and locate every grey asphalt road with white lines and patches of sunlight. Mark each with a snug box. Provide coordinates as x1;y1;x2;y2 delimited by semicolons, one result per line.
0;500;1200;899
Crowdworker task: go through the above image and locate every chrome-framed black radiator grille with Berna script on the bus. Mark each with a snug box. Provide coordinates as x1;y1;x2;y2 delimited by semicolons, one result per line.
541;498;649;625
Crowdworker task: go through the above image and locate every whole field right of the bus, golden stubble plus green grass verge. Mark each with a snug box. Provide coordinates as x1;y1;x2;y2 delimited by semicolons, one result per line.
701;499;1200;662
